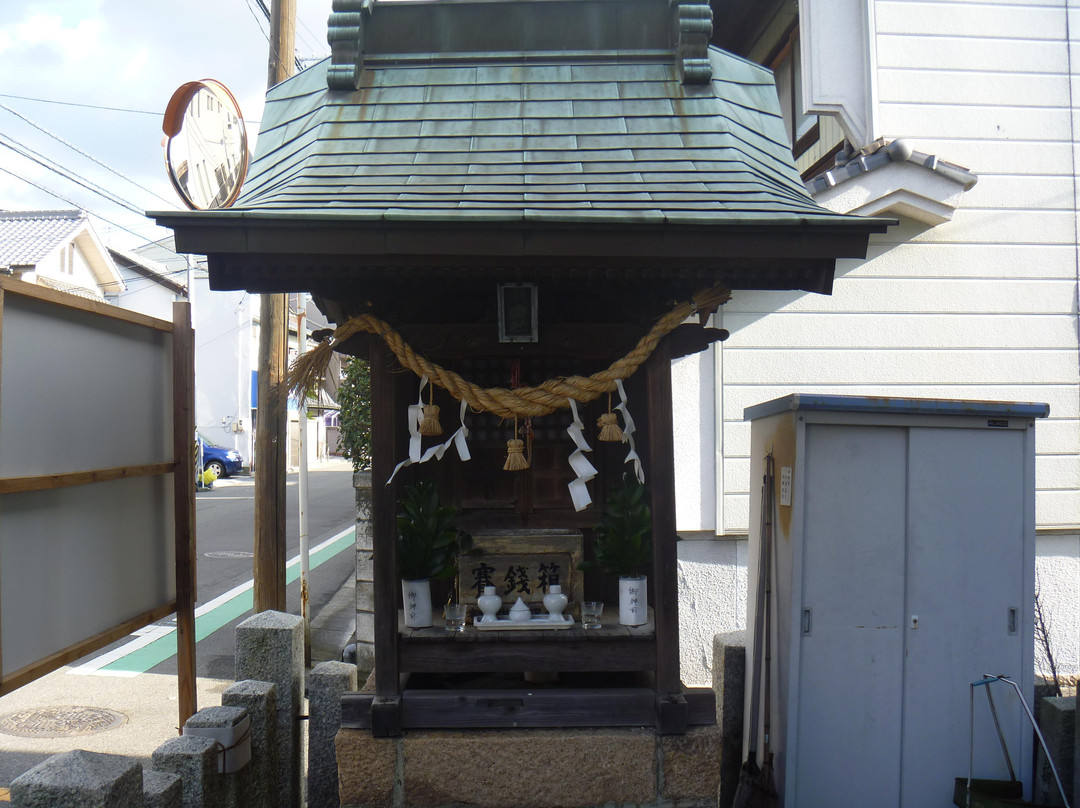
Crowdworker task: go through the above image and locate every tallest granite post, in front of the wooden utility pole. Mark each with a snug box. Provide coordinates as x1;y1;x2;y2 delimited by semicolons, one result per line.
237;611;303;808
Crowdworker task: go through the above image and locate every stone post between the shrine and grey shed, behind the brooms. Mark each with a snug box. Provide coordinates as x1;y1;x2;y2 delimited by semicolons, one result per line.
713;631;746;806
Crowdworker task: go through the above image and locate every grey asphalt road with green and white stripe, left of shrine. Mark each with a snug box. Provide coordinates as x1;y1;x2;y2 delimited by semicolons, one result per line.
77;461;355;679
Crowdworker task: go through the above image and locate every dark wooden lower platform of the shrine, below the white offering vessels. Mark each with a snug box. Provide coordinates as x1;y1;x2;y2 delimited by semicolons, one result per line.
341;609;716;735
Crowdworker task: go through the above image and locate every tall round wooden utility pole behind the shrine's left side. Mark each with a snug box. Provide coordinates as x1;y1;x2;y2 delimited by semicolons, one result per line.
253;0;296;612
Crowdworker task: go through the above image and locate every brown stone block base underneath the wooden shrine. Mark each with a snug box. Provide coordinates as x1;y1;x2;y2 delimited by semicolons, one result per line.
337;726;723;808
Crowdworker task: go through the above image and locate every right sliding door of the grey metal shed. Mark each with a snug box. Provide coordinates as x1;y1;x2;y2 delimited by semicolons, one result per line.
902;428;1030;808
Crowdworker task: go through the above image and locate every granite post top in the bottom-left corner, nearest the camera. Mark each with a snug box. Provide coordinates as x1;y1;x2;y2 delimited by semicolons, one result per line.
11;750;143;808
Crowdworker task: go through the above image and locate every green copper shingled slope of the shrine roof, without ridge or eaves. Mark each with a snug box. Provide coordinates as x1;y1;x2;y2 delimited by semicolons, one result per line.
234;49;850;225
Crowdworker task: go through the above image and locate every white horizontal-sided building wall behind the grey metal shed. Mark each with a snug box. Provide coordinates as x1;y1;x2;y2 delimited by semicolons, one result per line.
673;0;1080;682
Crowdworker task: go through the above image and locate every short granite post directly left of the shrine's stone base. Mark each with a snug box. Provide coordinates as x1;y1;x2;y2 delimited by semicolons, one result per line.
308;662;356;808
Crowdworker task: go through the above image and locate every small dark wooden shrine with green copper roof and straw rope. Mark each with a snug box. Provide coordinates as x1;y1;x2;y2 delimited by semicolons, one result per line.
154;0;890;737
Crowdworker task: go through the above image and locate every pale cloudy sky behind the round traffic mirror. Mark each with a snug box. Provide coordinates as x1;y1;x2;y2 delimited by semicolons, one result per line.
0;0;332;248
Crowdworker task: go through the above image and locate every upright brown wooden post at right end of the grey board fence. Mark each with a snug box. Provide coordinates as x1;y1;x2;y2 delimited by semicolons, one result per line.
173;302;199;727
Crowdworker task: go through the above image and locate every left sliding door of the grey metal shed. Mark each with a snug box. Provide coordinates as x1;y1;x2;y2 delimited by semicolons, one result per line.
785;425;911;808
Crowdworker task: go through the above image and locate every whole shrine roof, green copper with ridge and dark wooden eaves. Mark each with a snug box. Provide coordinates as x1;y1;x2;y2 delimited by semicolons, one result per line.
152;0;893;297
